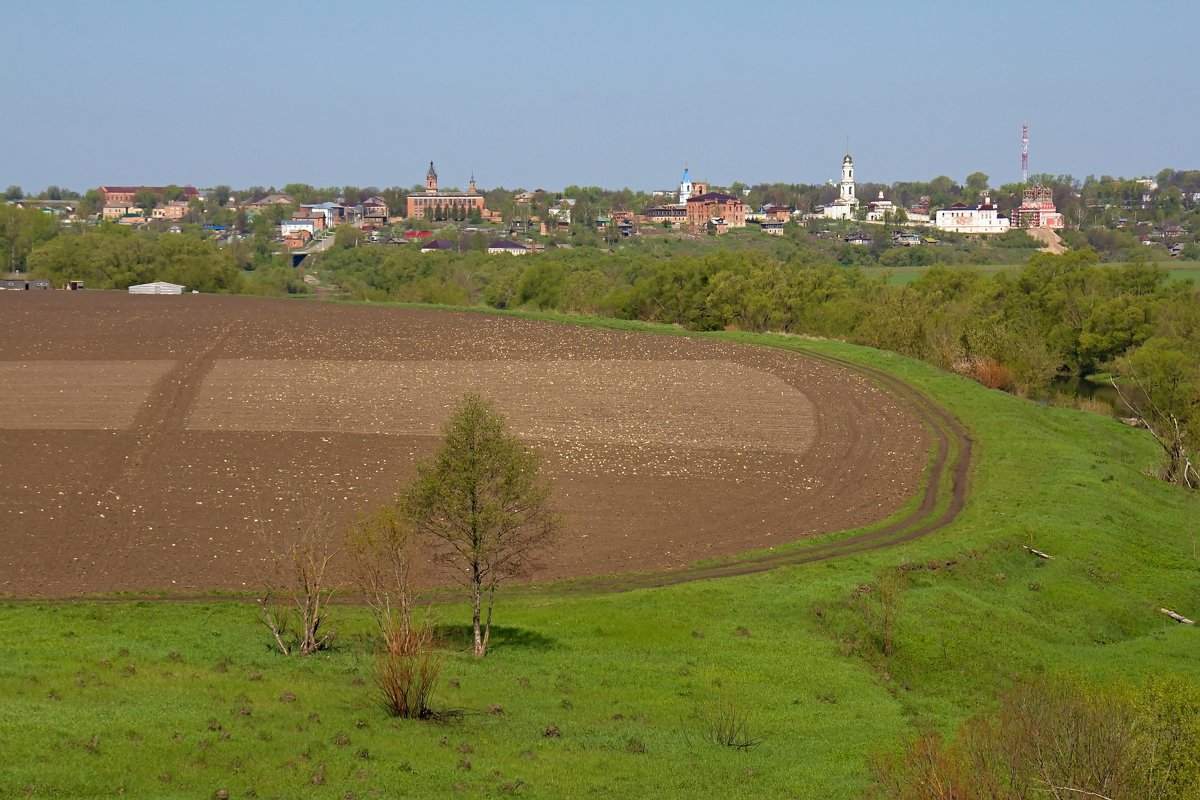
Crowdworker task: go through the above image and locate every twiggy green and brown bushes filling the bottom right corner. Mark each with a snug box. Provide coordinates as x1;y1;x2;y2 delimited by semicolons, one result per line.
866;676;1200;800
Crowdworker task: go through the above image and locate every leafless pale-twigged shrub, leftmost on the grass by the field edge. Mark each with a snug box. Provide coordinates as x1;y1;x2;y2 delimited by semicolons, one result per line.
258;510;336;656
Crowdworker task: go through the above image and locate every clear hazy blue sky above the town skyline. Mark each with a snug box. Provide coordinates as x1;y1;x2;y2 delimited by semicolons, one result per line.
0;0;1200;191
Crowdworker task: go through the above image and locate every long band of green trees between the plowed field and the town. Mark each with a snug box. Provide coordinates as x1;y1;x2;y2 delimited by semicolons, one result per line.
323;241;1200;483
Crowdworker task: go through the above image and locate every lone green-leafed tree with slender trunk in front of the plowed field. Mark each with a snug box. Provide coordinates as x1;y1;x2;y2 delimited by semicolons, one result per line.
400;395;559;657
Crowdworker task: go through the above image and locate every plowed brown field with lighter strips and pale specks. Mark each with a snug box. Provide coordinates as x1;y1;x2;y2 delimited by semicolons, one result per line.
0;291;929;596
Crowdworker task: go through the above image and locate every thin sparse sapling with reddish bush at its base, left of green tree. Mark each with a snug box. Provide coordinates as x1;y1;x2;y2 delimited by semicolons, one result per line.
346;506;442;720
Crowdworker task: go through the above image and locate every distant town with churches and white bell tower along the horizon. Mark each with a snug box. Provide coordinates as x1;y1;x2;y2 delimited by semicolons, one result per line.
5;152;1200;267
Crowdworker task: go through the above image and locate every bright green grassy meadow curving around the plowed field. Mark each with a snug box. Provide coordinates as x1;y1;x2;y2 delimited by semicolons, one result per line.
0;320;1200;800
